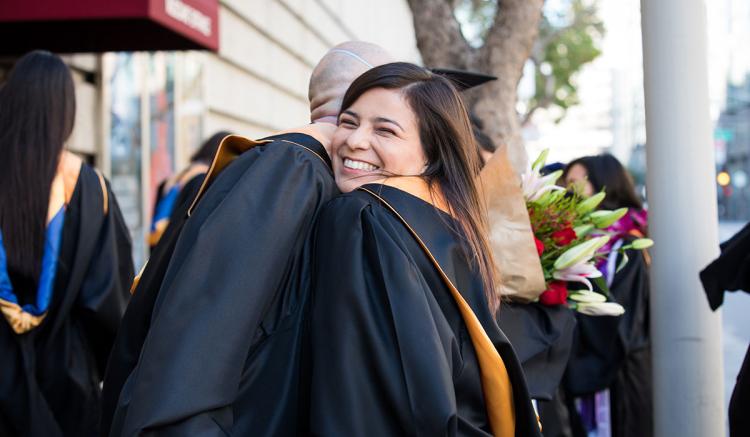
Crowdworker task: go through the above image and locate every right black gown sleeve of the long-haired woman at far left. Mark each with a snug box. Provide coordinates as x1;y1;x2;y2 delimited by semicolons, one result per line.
76;177;134;378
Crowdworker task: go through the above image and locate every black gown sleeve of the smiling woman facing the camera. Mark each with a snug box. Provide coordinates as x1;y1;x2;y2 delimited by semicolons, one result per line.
310;197;468;437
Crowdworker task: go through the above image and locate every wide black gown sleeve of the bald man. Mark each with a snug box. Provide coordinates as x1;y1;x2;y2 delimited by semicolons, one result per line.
117;143;335;436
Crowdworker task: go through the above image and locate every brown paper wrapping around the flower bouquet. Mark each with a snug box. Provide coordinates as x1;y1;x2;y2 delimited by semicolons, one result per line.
479;147;546;302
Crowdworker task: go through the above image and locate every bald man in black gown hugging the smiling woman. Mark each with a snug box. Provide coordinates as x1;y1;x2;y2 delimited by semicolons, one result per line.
102;42;391;436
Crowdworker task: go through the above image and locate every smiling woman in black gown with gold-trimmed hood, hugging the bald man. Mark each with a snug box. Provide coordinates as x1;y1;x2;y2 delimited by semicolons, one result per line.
310;63;539;437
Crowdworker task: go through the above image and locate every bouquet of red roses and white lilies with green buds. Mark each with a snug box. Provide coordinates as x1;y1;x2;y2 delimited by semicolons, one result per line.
522;150;653;316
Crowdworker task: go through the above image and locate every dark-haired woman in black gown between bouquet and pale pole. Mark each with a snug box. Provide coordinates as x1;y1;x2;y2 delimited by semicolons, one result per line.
562;154;653;437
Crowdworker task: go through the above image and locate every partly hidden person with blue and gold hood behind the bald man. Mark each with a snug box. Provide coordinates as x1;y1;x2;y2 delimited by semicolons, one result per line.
148;131;231;250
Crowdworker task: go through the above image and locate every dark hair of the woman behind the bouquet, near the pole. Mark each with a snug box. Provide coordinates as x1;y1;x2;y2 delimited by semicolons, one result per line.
562;153;643;209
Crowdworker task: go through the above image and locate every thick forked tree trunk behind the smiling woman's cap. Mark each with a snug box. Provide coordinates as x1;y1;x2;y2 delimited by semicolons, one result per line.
407;0;544;173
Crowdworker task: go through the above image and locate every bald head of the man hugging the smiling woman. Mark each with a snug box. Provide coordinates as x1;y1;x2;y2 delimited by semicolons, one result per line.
308;41;394;121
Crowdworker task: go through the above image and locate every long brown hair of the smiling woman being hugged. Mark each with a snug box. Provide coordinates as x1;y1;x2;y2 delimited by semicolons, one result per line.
341;62;499;311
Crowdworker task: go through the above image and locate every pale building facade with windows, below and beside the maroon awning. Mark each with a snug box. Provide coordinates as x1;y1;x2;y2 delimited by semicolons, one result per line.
0;0;420;265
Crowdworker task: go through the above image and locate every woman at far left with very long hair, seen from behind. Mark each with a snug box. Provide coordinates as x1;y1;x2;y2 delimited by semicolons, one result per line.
0;51;133;437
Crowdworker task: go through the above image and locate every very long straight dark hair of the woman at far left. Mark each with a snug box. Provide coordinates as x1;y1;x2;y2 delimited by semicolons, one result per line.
0;51;76;295
